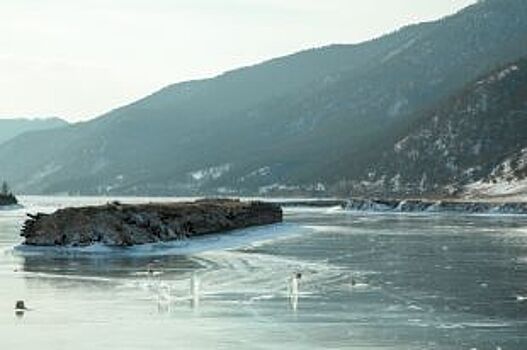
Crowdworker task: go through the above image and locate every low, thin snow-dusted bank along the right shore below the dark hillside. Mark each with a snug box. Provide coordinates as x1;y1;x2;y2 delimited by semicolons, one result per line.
346;198;527;214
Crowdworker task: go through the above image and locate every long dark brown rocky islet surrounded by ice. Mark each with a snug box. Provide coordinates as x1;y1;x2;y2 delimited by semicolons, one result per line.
21;199;282;247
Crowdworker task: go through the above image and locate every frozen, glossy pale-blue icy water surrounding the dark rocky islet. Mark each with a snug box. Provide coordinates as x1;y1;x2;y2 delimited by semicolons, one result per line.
0;197;527;350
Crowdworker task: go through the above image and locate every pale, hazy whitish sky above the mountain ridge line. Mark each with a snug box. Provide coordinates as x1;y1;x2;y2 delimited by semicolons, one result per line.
0;0;475;121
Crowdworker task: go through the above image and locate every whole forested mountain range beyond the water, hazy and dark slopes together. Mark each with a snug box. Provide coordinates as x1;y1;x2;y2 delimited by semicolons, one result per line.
0;0;527;197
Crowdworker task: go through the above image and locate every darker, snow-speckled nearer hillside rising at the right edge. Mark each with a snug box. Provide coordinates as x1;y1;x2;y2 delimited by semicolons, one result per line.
341;58;527;197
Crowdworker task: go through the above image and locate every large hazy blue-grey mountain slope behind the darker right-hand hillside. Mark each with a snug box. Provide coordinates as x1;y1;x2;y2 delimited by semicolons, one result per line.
0;0;527;195
